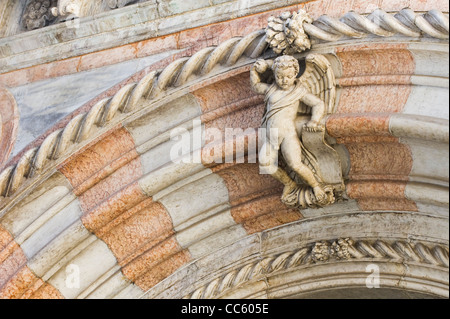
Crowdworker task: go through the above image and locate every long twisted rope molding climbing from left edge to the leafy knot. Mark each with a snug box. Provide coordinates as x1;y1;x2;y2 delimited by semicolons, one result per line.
0;30;267;197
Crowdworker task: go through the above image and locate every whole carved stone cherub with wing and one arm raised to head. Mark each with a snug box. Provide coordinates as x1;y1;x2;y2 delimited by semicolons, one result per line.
250;54;334;206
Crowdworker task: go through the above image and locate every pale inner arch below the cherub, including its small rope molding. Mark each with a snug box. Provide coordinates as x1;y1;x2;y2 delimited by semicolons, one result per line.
153;212;448;299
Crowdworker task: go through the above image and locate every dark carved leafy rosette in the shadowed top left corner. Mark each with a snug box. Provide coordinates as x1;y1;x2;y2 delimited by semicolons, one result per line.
22;0;58;30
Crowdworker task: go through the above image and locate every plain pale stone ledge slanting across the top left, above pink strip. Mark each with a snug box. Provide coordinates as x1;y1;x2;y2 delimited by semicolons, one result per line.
0;0;310;73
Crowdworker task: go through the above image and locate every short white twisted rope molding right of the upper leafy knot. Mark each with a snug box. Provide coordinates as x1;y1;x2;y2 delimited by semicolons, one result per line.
303;9;449;42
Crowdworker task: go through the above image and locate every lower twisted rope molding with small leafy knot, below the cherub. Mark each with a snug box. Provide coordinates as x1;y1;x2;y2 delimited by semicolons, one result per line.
183;238;449;299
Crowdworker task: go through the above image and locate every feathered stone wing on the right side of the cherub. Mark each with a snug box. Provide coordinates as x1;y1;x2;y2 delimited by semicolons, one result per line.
300;53;336;114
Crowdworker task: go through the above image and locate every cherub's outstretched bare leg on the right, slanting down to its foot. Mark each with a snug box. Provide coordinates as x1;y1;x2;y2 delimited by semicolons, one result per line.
281;135;327;202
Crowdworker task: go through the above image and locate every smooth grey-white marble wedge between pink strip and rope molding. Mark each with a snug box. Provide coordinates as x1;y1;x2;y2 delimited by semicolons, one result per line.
7;51;178;157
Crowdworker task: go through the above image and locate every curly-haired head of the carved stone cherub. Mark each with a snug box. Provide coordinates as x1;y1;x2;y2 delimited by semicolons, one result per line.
272;55;300;90
